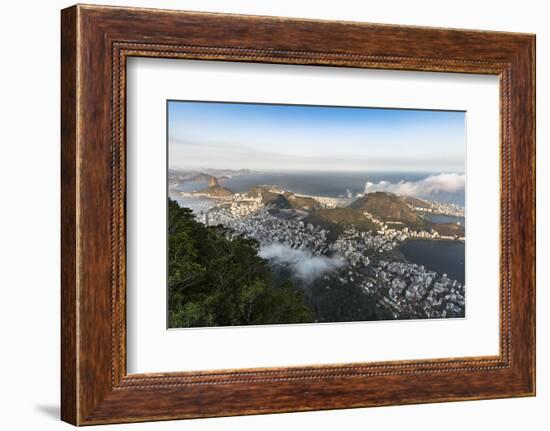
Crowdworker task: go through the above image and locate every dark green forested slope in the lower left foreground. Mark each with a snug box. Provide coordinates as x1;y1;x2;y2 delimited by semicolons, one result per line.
168;199;313;328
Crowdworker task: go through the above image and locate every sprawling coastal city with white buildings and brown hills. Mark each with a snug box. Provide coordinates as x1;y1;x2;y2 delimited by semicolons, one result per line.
169;170;465;321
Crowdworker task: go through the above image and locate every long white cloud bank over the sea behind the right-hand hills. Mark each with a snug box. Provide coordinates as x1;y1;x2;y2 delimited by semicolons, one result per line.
365;174;466;197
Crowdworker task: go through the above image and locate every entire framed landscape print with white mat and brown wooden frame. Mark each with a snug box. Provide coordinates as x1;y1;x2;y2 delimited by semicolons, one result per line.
61;5;535;425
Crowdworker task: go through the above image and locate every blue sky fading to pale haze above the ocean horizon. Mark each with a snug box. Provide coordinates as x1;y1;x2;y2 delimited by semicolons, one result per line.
168;101;466;172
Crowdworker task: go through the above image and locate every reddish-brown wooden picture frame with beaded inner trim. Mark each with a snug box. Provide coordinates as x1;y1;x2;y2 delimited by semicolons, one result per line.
61;5;535;425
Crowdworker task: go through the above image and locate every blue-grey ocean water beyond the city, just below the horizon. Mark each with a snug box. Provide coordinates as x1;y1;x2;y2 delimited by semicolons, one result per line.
171;172;465;206
